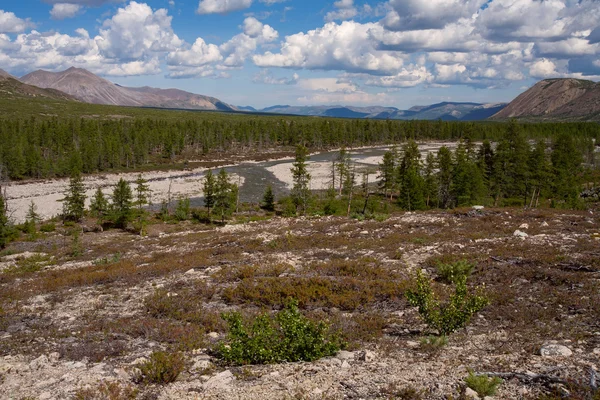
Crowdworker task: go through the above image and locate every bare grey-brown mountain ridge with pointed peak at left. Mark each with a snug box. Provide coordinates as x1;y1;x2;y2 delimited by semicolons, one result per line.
21;67;236;111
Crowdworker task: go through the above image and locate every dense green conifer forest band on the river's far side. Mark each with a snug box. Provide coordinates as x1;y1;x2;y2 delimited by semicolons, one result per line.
0;115;600;180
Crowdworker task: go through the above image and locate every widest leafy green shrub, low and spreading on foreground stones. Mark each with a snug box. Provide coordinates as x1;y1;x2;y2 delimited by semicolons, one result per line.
218;300;344;365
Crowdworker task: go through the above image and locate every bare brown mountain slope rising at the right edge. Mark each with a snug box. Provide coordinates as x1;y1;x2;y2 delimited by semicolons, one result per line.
492;78;600;120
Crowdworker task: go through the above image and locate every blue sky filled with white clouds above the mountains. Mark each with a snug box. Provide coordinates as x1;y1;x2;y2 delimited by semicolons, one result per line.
0;0;600;109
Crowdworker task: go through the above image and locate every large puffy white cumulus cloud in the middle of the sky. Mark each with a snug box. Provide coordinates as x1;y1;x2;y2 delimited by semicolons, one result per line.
253;21;403;74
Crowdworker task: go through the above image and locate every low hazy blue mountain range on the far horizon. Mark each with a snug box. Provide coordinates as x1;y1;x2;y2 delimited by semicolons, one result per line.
251;102;506;121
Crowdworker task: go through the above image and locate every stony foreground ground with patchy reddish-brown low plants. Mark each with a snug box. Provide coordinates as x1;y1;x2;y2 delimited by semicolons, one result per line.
0;209;600;399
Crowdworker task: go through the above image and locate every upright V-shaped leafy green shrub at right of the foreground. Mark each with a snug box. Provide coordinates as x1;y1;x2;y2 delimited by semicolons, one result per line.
406;271;489;335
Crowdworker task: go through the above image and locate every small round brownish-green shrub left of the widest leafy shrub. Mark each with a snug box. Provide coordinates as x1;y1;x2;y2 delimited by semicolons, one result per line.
137;351;185;384
